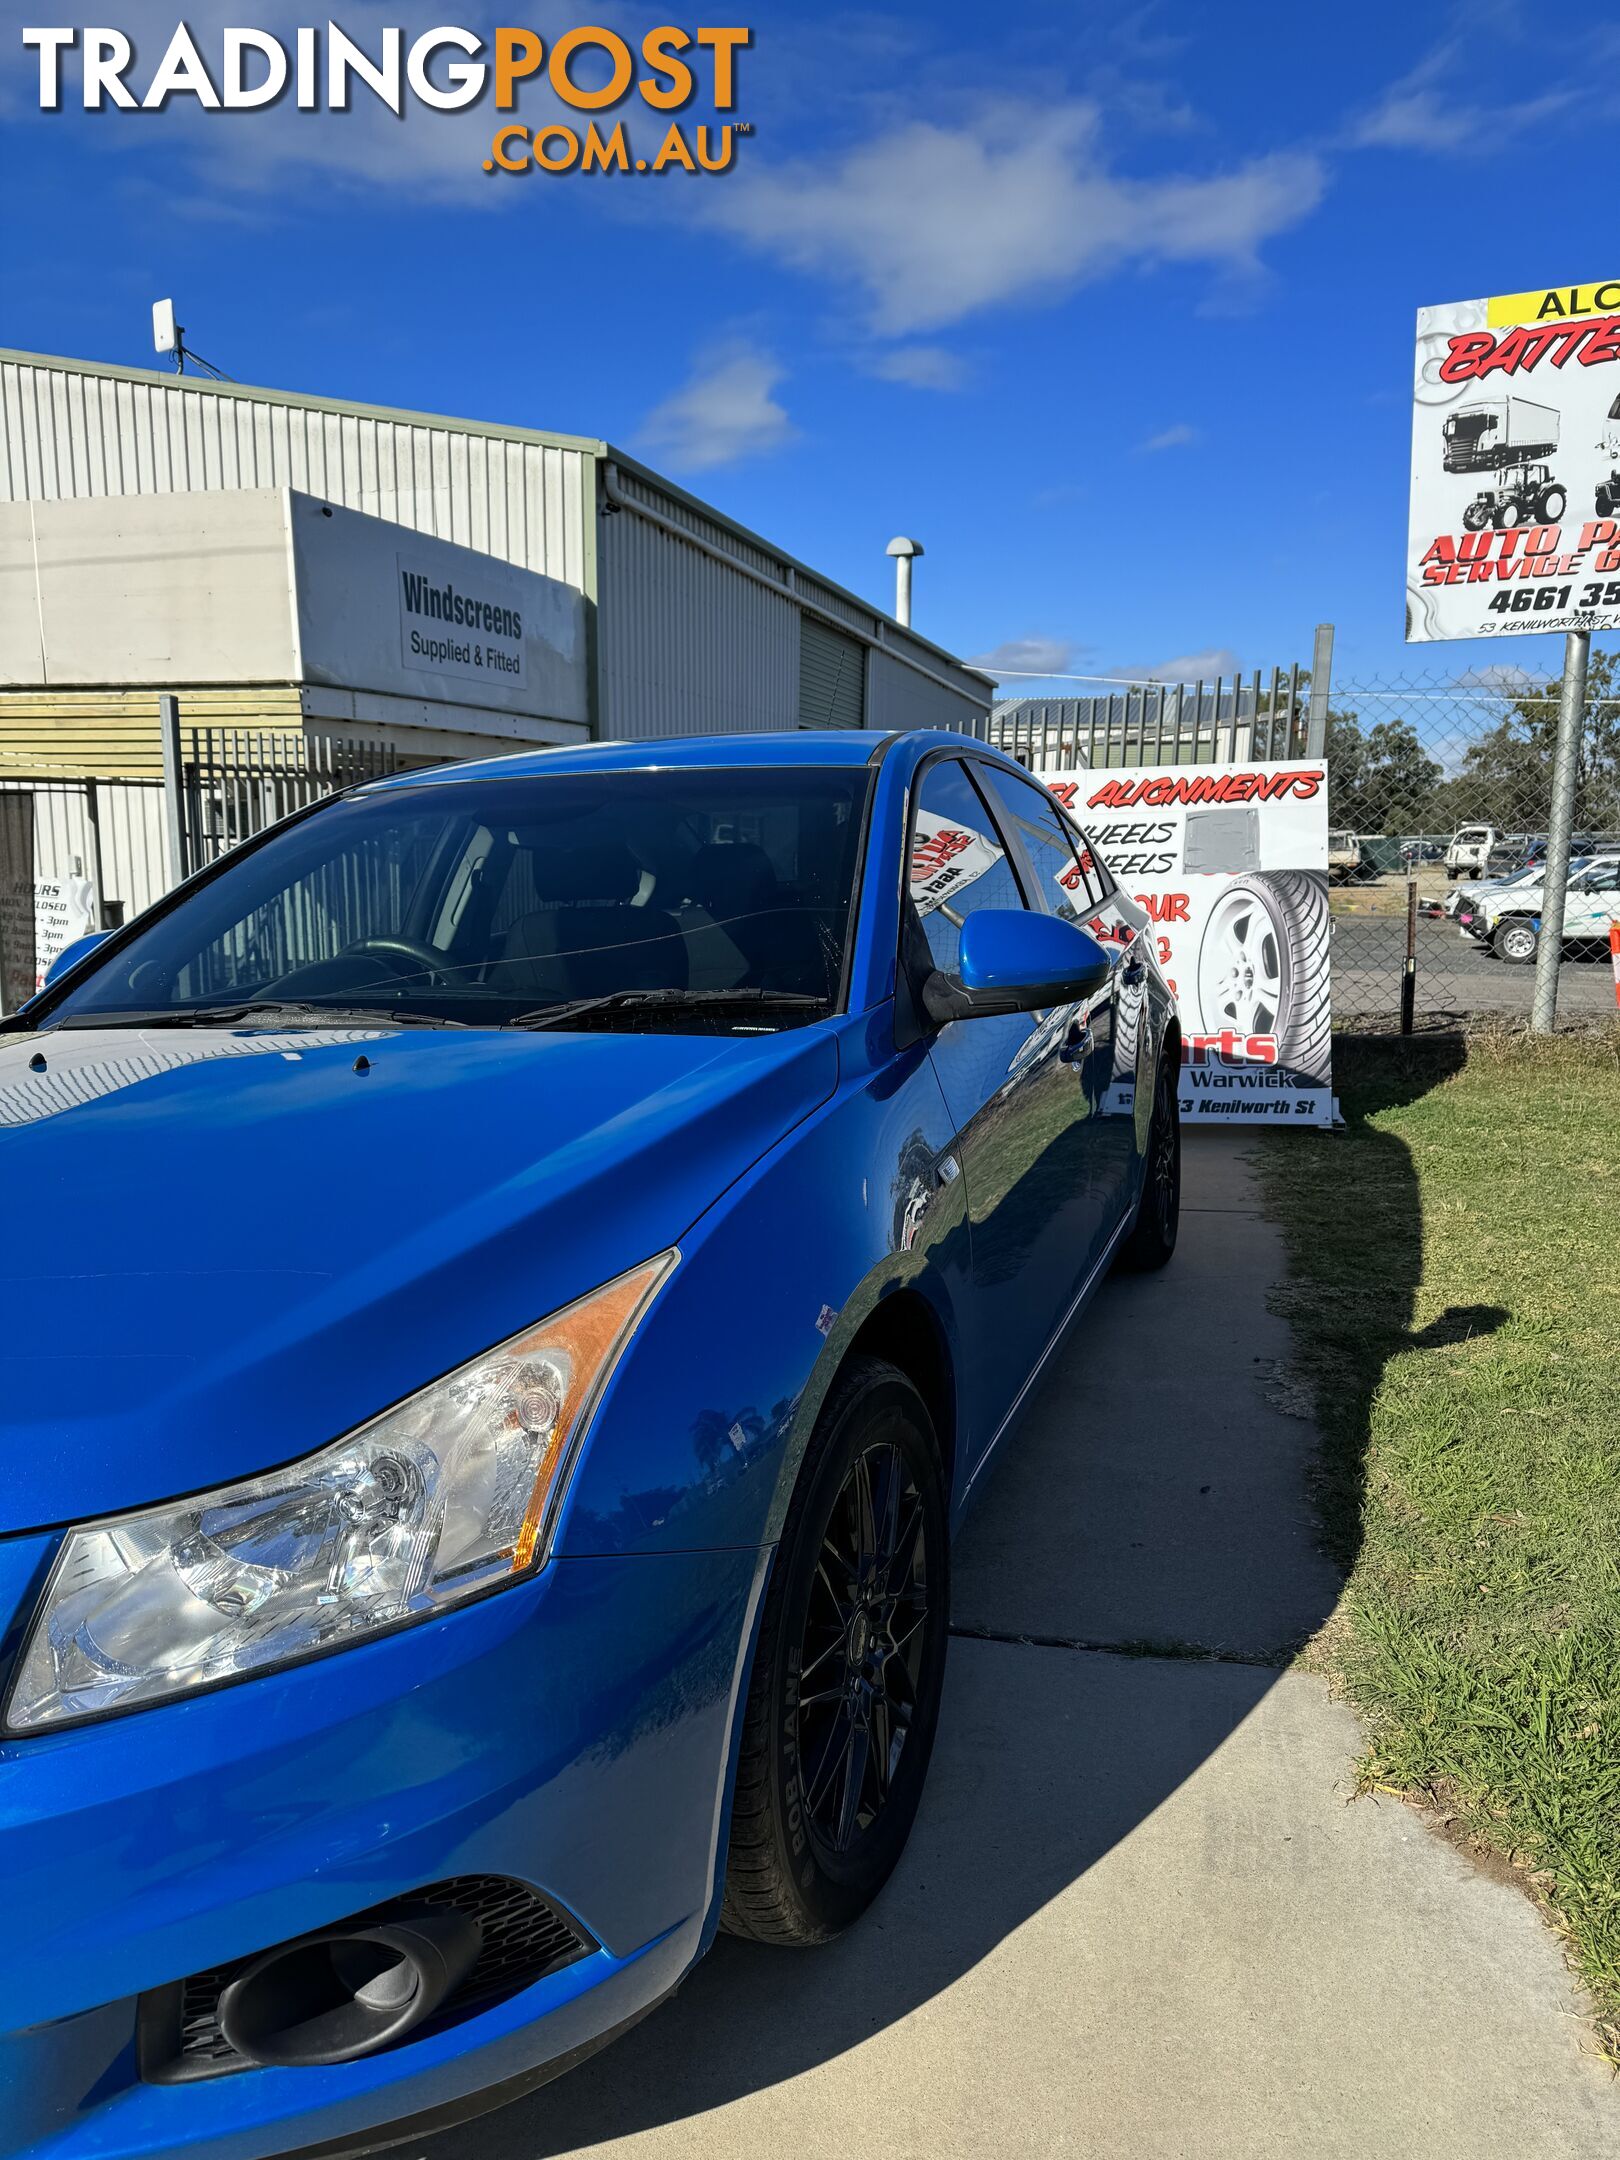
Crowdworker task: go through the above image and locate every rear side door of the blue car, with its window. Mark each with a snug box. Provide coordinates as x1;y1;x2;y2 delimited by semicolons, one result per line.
981;762;1147;1261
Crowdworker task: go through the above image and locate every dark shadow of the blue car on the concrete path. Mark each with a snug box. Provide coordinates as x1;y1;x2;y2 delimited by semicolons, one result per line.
427;1043;1501;2160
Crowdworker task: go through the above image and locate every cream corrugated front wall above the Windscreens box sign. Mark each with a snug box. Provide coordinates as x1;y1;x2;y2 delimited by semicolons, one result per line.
0;361;596;590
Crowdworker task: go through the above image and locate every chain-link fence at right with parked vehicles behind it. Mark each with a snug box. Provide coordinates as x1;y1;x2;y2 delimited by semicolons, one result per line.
1326;652;1620;1030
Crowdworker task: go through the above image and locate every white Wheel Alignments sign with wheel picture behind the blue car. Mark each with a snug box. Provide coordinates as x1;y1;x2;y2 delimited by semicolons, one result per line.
1048;758;1333;1125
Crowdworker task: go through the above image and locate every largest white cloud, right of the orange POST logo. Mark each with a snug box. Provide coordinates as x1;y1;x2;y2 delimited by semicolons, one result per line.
704;102;1324;337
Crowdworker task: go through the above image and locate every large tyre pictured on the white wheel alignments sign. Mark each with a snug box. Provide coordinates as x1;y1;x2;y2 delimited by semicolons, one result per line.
1199;870;1333;1080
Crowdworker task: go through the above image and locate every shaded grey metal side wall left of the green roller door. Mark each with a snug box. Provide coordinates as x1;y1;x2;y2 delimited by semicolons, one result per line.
596;490;799;741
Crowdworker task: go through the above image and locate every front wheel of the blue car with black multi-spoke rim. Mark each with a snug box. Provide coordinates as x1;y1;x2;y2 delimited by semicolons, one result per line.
721;1359;950;1944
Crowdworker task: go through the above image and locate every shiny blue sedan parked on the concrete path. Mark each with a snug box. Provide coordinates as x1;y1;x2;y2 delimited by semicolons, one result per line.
0;732;1179;2160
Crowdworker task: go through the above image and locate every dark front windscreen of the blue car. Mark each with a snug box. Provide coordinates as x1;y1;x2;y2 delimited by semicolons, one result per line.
43;767;870;1030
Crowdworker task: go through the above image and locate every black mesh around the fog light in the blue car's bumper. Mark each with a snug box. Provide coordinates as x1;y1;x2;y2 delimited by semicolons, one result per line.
140;1875;596;2084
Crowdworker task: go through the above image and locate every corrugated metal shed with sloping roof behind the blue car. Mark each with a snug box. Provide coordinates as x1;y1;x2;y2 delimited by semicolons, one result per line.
0;352;991;775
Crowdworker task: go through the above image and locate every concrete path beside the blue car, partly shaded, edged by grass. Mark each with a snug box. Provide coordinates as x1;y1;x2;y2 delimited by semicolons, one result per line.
425;1134;1620;2160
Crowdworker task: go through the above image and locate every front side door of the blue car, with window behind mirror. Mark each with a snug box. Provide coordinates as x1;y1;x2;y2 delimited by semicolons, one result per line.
907;758;1097;1460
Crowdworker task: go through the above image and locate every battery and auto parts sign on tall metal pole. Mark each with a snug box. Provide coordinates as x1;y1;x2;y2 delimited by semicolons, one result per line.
1406;279;1620;642
